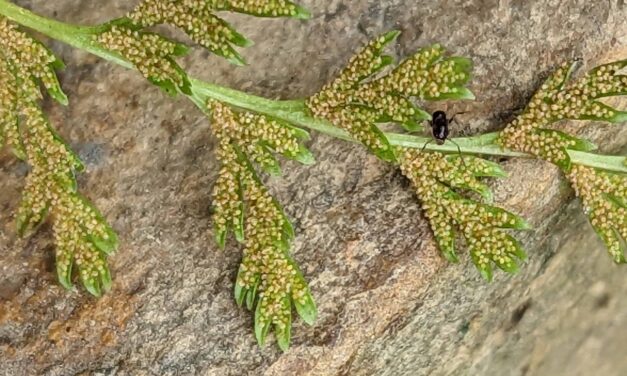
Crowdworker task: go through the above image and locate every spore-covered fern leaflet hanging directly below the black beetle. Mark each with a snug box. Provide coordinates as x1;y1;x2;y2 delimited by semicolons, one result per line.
397;148;530;280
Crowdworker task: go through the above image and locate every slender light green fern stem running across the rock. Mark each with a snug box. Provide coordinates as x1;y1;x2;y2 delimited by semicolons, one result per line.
0;0;627;173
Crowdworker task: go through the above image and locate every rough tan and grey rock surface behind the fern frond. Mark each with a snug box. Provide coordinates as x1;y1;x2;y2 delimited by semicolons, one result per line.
0;0;627;376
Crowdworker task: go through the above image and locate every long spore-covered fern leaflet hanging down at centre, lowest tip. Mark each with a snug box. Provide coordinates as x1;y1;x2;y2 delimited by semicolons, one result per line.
208;100;316;350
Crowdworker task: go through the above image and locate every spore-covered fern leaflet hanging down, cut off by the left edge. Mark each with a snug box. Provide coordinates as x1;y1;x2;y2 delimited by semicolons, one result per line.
0;17;117;296
